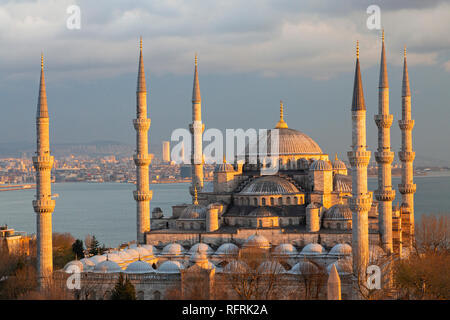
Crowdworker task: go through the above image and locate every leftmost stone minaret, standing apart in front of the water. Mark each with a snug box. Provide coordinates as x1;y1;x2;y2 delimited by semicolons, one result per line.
33;55;55;288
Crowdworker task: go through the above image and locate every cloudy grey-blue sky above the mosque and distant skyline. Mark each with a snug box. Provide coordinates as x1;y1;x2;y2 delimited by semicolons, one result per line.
0;0;450;161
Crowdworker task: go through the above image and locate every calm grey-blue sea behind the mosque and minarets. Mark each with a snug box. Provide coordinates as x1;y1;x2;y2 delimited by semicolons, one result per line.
0;174;450;247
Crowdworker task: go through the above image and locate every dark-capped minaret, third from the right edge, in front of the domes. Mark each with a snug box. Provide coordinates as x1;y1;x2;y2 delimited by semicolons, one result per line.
348;42;372;279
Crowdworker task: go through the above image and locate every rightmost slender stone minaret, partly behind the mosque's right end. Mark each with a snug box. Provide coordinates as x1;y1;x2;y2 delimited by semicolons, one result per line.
398;47;416;245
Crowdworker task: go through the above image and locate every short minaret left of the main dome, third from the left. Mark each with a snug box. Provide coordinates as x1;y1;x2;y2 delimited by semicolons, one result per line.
189;54;205;196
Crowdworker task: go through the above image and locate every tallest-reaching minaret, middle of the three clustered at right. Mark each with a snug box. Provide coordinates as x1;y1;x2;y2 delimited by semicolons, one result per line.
375;30;395;254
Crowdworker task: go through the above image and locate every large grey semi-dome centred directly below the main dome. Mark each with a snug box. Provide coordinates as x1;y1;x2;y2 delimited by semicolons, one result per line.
240;176;300;195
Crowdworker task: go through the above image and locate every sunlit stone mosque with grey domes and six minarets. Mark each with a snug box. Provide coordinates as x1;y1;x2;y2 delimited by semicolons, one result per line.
33;32;416;299
